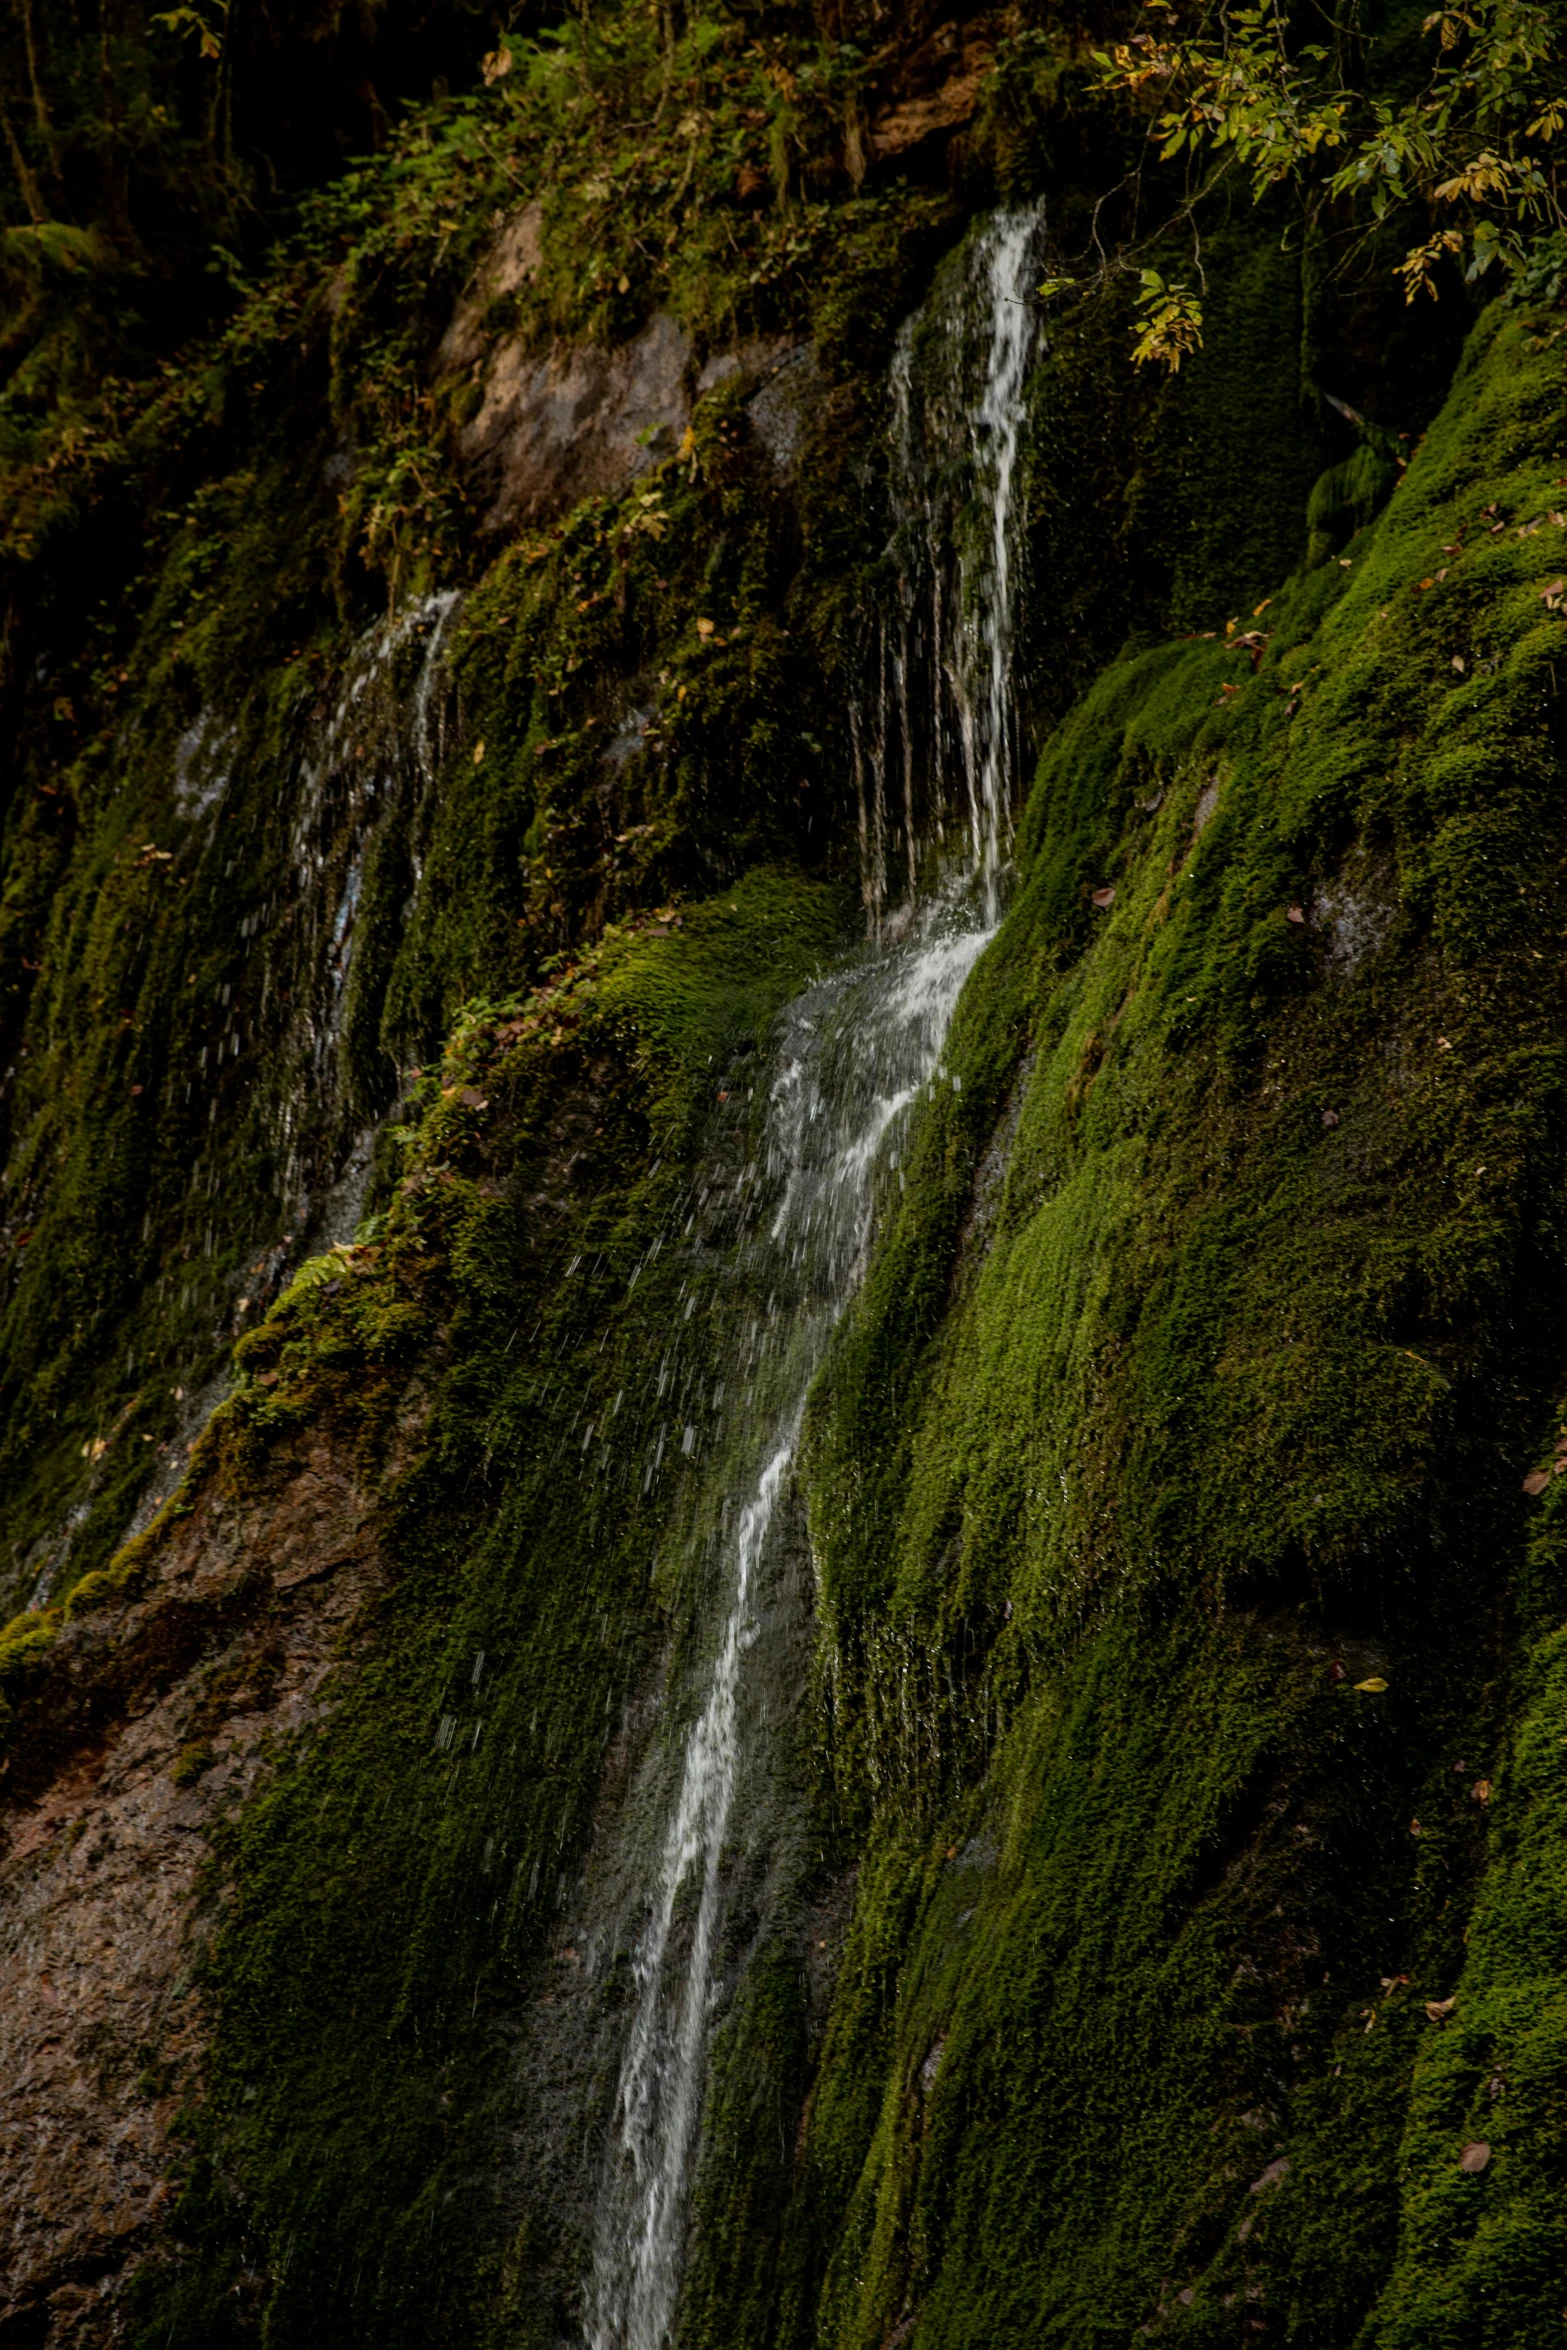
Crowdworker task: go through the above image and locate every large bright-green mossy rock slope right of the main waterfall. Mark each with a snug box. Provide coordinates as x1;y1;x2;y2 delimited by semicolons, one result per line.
732;315;1567;2345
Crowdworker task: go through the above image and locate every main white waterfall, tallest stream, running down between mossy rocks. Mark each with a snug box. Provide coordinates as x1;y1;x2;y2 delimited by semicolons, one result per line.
587;212;1038;2350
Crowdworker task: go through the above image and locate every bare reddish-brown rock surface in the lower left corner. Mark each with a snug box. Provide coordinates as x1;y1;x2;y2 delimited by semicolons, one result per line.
0;1441;399;2350
